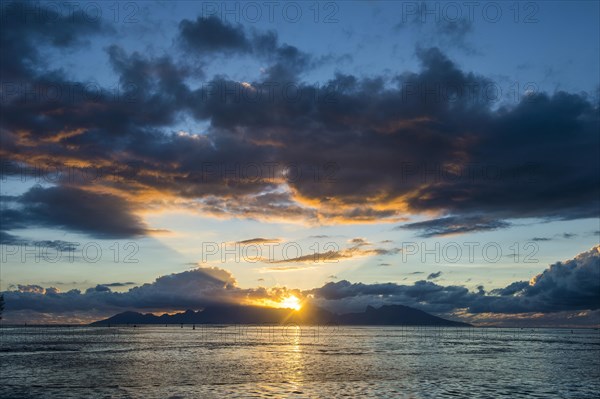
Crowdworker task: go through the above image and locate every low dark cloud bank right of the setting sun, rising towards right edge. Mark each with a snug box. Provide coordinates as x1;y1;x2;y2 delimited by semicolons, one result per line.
311;246;600;314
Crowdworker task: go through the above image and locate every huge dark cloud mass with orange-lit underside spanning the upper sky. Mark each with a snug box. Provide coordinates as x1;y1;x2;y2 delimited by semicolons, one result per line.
0;1;600;236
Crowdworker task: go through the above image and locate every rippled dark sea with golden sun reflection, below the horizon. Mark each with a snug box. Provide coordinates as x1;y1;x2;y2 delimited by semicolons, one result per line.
0;326;600;399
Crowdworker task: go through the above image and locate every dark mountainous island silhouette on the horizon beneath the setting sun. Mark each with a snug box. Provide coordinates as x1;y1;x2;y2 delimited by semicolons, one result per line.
90;305;471;327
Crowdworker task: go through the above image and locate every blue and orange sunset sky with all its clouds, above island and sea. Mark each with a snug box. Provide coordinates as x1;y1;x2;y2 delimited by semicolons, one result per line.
0;1;600;326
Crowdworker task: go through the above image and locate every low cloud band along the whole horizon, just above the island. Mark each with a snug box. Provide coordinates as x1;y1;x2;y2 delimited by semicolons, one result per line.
4;246;600;320
